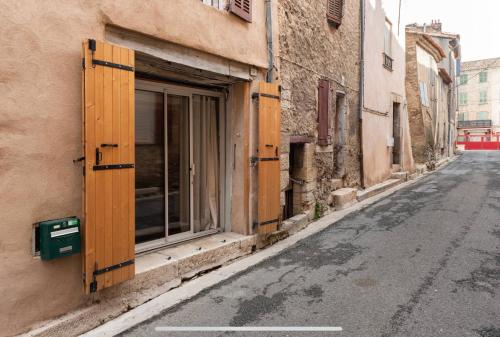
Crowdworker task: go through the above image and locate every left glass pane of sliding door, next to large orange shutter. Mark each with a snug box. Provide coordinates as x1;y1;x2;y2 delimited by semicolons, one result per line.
135;90;165;243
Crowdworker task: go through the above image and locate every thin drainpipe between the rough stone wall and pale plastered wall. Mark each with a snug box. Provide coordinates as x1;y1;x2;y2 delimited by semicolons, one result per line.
358;0;365;188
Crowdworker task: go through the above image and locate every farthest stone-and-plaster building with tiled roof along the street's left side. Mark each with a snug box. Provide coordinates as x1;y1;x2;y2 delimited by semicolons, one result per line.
406;22;460;164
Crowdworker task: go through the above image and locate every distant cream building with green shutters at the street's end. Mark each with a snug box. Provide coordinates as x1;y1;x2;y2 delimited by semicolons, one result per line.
457;58;500;140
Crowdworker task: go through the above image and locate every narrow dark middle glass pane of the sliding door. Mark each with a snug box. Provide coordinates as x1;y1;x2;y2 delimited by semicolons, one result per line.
167;94;191;236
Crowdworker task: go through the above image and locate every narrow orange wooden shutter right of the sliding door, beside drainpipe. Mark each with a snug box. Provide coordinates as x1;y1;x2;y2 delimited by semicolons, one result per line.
257;83;281;233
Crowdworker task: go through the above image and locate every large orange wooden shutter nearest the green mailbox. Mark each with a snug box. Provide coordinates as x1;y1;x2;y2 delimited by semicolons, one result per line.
83;40;135;293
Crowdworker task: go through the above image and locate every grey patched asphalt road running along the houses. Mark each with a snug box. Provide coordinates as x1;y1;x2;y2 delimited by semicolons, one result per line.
123;151;500;337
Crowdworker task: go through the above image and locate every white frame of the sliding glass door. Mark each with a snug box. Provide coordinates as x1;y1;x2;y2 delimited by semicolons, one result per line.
134;79;227;253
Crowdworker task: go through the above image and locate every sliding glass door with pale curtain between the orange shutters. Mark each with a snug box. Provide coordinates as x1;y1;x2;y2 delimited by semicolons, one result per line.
136;81;224;247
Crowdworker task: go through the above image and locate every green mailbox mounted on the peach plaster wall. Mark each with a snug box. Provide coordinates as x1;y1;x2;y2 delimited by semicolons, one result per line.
39;217;81;260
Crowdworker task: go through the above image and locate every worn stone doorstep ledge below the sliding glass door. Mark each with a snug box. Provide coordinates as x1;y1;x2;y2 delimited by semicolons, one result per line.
21;232;256;337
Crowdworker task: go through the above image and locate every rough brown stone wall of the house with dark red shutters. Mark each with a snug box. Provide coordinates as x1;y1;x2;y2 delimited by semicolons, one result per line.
278;0;360;212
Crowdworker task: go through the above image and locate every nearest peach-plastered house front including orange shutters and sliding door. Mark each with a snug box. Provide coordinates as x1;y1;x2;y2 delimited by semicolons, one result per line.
0;0;281;335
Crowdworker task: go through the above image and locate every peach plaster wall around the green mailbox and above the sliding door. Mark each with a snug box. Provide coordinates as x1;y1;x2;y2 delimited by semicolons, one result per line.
0;0;277;335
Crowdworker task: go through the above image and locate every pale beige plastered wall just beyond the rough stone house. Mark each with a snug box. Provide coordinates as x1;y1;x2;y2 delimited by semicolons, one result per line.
363;0;413;187
